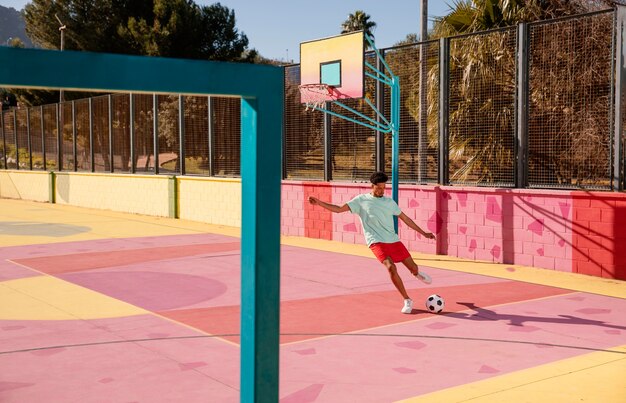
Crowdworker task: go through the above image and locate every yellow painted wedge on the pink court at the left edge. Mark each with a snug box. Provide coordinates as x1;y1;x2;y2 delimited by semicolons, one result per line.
0;276;150;320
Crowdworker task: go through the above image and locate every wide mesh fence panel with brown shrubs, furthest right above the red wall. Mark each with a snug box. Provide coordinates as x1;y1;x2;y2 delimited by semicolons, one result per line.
528;13;614;189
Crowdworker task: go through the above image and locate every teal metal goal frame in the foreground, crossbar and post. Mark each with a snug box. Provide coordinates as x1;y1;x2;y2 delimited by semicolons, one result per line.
0;47;284;402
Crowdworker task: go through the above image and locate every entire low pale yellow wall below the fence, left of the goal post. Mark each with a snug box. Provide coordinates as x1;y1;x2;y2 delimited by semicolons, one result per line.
0;171;241;227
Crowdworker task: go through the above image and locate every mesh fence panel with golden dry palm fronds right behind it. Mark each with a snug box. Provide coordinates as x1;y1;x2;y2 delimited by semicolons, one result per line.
448;28;516;187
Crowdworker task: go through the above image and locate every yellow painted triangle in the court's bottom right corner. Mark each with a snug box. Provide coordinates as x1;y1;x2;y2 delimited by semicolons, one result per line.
402;345;626;403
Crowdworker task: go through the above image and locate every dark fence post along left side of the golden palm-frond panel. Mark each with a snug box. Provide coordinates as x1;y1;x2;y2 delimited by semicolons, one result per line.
439;38;450;185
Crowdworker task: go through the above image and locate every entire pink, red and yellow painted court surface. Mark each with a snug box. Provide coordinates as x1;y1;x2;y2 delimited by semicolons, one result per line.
0;199;626;403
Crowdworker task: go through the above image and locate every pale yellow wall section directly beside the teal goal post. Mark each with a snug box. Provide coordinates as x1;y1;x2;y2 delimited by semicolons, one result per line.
177;177;241;227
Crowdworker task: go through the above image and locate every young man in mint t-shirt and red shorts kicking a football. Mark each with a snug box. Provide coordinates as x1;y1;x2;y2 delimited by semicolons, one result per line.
309;172;435;313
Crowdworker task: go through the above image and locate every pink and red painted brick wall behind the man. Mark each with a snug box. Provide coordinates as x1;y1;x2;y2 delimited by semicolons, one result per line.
282;181;626;279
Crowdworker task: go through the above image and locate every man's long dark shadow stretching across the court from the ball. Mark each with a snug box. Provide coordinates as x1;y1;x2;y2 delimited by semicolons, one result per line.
444;302;626;330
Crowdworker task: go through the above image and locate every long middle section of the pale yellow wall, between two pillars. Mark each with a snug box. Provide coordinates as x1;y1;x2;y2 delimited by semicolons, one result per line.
55;172;169;217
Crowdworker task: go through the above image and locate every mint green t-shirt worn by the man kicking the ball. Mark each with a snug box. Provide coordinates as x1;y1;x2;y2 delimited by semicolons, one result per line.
348;193;402;246
